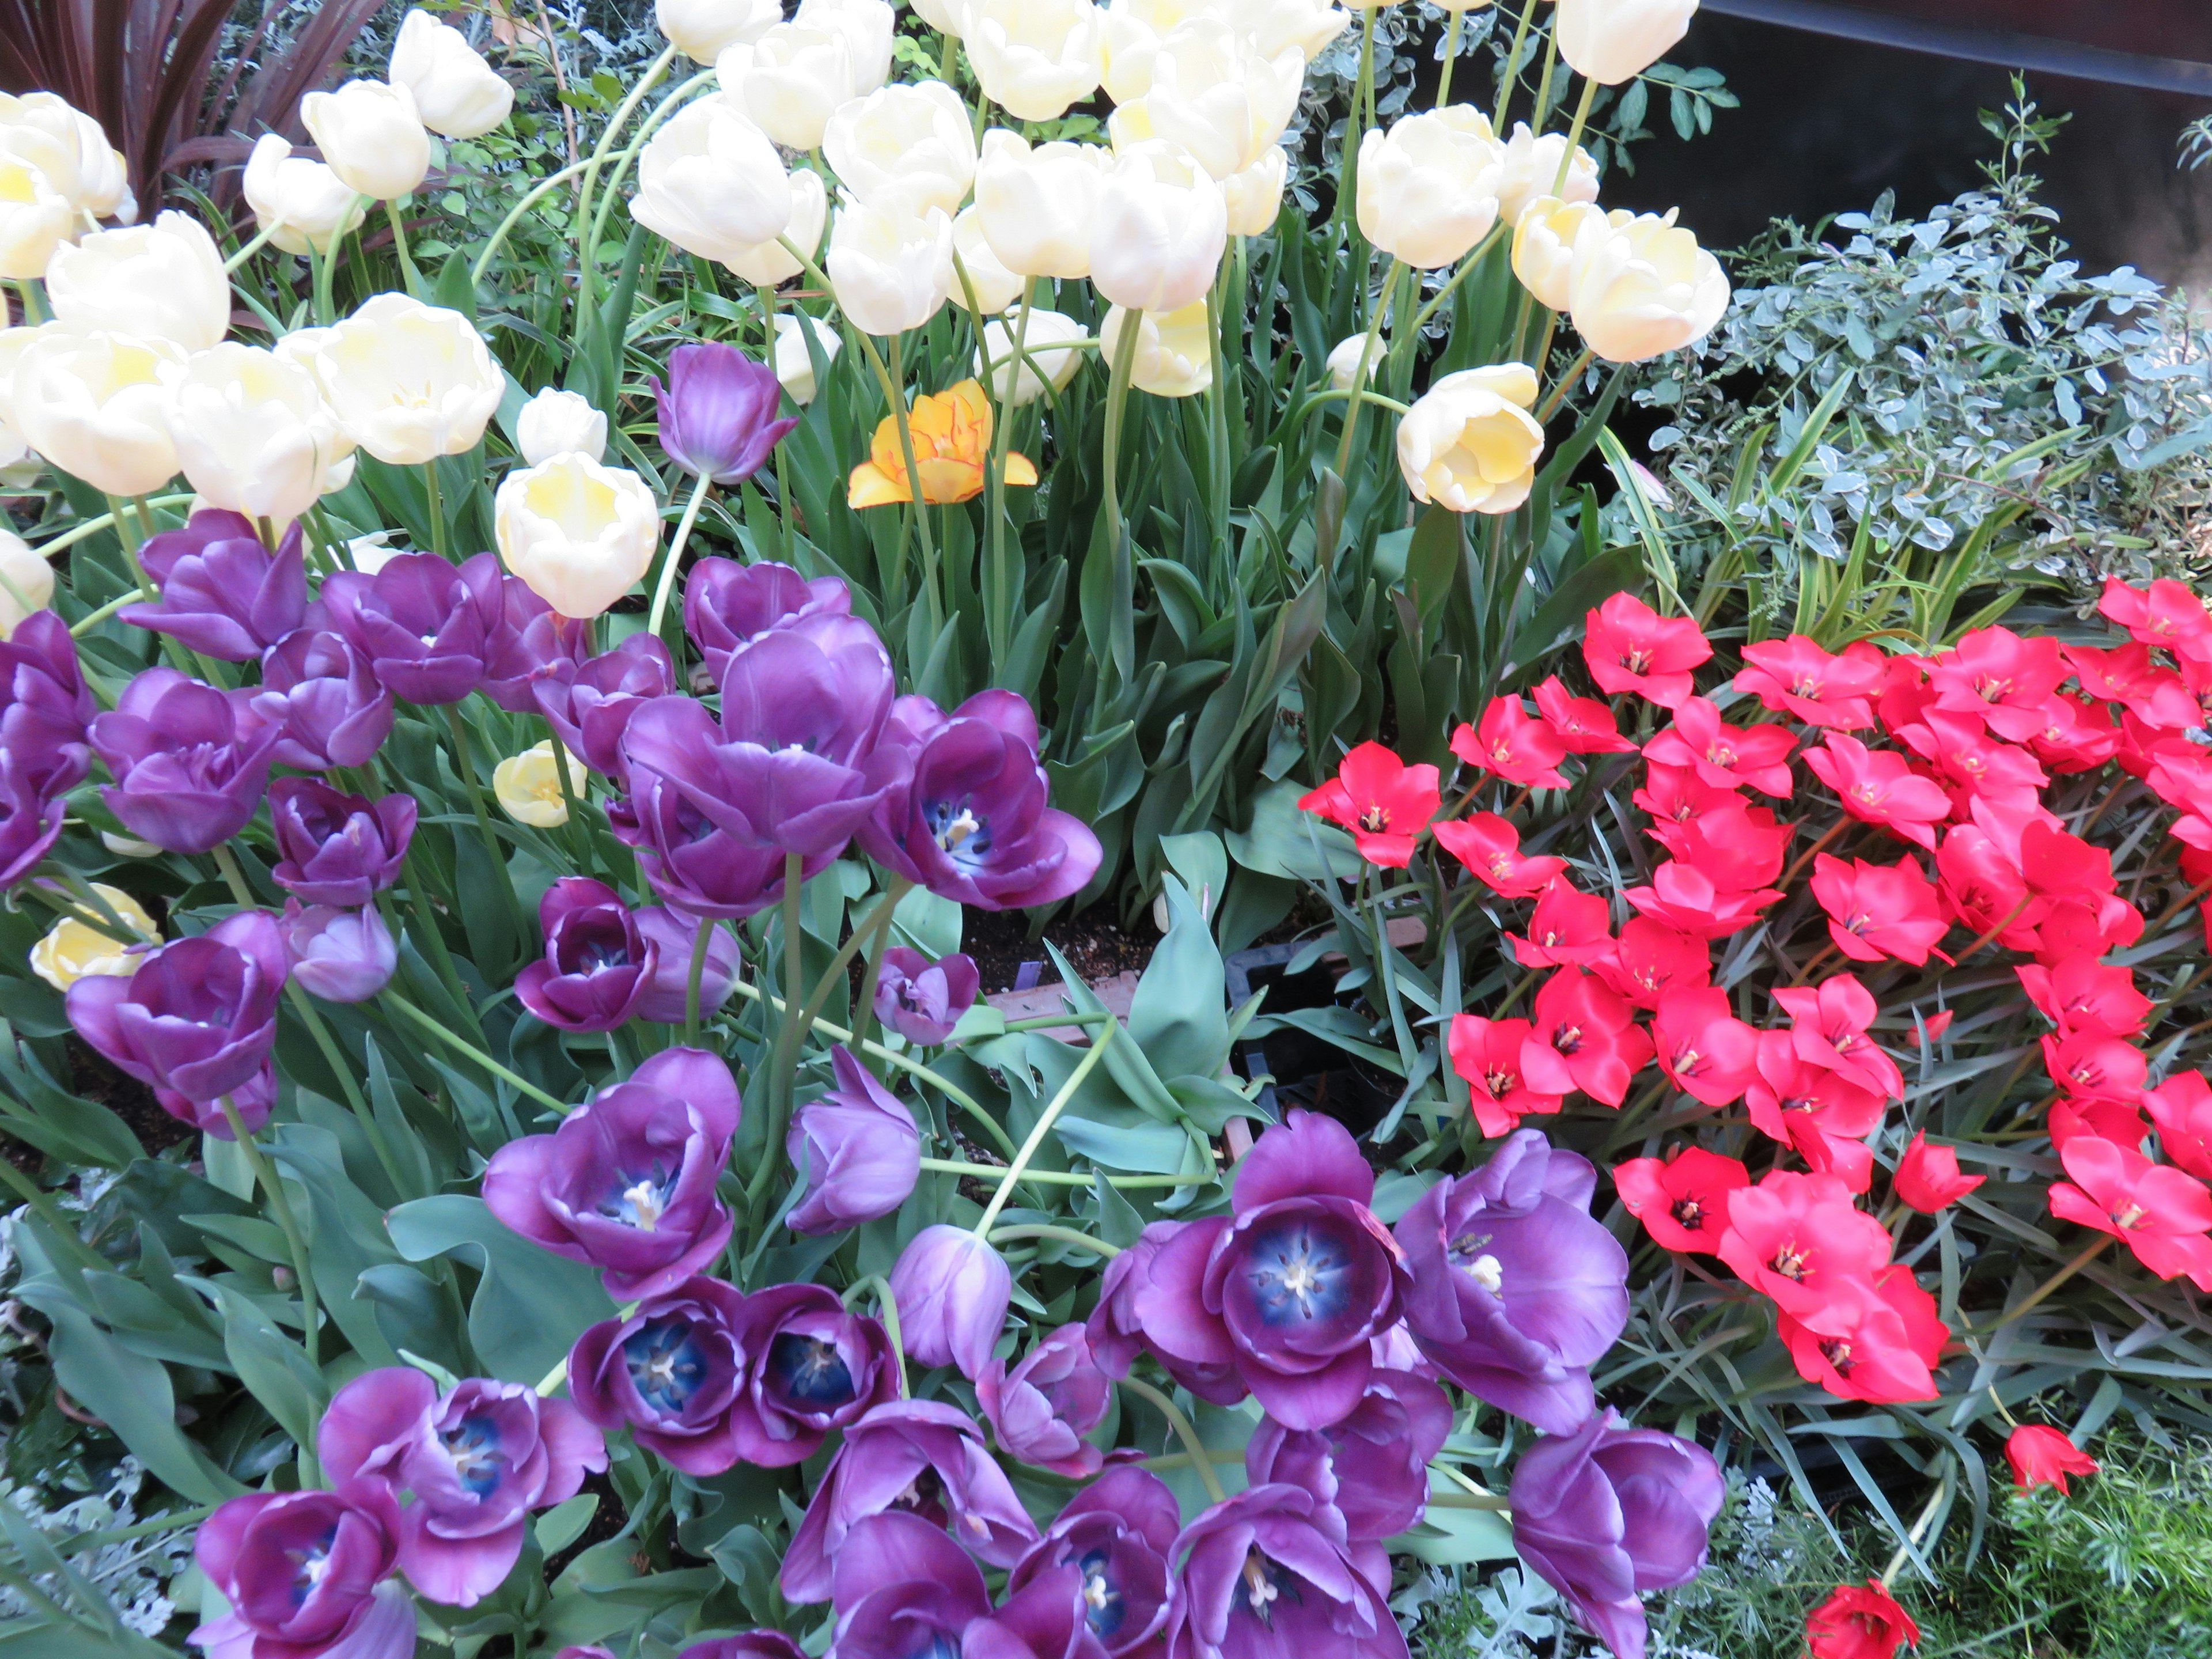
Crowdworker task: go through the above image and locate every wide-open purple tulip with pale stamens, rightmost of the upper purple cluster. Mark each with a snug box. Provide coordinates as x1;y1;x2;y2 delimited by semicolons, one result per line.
861;690;1104;909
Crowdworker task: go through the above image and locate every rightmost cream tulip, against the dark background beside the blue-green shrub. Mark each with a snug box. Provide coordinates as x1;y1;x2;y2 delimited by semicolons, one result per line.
1566;210;1728;363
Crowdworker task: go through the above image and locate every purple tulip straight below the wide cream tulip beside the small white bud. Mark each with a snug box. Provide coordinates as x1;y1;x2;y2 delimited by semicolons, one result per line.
321;553;506;703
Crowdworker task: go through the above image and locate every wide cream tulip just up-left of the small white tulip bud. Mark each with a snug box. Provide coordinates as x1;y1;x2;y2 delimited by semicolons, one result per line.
308;294;506;467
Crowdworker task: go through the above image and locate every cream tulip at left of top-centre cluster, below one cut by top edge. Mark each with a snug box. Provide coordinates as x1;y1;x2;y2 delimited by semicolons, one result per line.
630;100;792;259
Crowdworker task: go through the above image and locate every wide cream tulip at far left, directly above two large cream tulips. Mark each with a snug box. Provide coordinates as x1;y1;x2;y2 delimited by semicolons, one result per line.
47;213;230;352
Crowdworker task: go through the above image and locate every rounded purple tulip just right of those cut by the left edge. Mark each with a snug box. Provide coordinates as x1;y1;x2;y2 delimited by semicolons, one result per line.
90;668;276;851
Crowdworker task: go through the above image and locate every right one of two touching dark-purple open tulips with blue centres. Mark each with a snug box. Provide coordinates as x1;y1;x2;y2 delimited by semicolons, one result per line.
730;1285;898;1469
